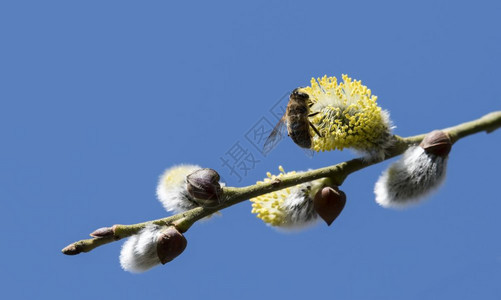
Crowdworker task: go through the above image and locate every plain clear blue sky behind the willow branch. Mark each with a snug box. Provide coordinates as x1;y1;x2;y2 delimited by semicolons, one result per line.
0;1;501;299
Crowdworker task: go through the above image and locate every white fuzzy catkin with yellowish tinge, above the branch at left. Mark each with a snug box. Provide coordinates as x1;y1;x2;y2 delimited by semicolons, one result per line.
157;165;201;213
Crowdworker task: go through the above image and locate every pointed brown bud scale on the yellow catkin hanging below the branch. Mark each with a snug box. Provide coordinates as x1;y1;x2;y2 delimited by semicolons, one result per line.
313;186;346;226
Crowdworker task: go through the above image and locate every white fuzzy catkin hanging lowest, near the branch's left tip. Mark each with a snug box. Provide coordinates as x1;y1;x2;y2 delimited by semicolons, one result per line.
120;225;162;273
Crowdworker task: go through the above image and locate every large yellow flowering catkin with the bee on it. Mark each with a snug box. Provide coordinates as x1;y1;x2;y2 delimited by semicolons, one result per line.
301;75;393;160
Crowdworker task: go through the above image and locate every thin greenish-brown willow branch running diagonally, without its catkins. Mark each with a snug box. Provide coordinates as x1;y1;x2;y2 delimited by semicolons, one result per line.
62;111;501;255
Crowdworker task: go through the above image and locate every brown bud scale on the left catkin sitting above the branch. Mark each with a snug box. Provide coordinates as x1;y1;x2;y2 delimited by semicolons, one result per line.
186;169;222;206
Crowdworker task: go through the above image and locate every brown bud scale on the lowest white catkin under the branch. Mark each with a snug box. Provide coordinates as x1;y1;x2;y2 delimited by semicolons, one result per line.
157;226;188;265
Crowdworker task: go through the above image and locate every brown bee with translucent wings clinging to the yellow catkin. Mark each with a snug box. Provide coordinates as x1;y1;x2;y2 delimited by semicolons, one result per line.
263;88;322;154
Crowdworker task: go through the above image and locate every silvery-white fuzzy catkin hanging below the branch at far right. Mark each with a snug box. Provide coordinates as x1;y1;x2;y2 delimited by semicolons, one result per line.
374;146;448;208
